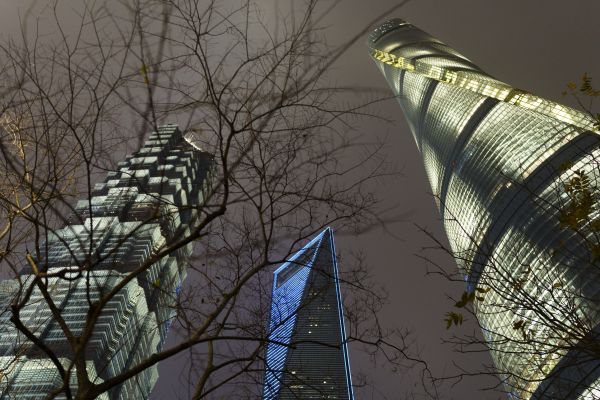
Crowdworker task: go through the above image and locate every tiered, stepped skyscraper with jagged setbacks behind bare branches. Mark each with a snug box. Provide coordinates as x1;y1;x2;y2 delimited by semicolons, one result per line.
0;125;211;399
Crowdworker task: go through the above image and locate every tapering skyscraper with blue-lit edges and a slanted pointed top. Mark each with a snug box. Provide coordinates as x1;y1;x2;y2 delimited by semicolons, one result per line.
263;228;353;400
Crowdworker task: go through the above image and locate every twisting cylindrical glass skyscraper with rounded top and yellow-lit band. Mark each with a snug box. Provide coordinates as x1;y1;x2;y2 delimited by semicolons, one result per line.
369;19;600;399
